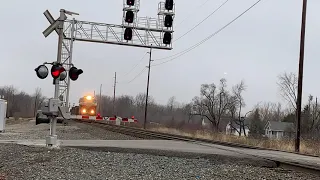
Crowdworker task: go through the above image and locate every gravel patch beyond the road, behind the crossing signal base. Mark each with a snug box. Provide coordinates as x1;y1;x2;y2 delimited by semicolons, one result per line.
0;120;138;140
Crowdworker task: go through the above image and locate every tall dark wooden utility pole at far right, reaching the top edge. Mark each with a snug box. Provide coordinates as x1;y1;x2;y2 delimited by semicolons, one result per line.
295;0;307;152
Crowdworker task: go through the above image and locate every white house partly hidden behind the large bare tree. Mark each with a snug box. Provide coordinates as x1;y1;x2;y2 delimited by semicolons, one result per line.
226;120;250;136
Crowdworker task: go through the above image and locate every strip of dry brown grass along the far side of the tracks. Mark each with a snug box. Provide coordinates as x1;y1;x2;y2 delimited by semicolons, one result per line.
149;127;320;156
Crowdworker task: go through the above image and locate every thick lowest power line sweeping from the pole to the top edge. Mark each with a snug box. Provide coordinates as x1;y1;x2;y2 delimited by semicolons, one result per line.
153;0;262;66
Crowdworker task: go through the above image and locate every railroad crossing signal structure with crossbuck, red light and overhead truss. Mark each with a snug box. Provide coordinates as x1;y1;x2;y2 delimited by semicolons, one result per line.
39;0;175;145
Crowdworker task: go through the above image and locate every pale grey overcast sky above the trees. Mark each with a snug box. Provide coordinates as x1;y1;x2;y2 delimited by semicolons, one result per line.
0;0;320;114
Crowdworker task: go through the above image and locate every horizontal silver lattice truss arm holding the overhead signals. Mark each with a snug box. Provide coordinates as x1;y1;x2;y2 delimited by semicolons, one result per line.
65;20;174;50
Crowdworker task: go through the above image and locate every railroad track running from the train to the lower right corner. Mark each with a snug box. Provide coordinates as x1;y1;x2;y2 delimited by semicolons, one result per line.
75;120;320;175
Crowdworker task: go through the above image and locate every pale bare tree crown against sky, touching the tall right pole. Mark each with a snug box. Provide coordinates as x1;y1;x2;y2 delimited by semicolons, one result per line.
278;72;298;111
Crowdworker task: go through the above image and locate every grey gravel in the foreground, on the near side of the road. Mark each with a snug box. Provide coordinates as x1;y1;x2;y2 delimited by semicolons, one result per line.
0;144;320;180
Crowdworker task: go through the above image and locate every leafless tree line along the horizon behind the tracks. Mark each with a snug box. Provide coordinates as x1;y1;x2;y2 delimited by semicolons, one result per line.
0;73;320;137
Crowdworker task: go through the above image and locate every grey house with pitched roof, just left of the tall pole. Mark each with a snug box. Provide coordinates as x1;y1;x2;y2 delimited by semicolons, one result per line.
264;121;294;139
